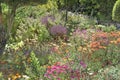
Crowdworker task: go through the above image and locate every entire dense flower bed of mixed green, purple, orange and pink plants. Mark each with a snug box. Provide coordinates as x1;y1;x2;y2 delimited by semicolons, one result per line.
0;0;120;80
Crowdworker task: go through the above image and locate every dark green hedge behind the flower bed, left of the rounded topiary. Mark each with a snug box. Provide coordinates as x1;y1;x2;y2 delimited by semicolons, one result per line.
57;0;116;20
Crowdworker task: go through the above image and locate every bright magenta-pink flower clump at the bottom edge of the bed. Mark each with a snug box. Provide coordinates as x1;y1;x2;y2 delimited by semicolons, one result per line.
44;61;87;80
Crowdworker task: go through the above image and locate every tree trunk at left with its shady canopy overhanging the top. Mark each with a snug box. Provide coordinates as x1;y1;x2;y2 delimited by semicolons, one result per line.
0;0;47;42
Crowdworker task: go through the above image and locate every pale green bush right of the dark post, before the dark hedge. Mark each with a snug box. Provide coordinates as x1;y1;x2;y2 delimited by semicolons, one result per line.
67;12;97;32
